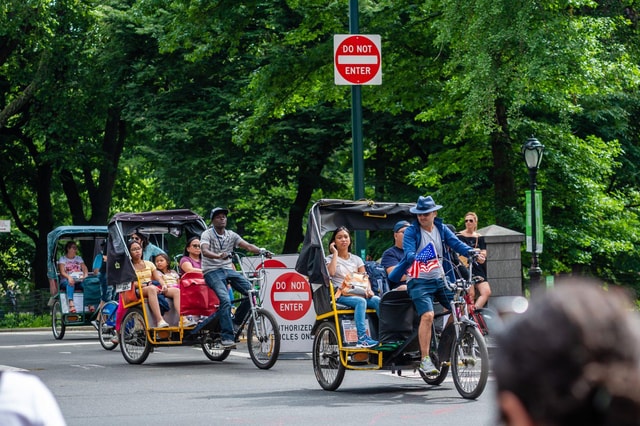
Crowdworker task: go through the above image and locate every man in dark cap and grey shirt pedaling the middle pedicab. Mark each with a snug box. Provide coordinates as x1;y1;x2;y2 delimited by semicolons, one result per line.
200;207;268;348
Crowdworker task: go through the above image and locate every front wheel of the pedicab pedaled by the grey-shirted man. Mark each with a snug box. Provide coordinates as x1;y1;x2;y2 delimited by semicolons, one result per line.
247;309;280;370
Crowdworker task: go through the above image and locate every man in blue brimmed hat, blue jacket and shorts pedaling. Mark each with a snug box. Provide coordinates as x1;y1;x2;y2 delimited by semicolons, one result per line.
389;196;482;374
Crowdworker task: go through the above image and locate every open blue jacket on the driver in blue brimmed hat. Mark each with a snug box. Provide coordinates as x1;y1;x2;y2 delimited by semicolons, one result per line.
389;217;473;282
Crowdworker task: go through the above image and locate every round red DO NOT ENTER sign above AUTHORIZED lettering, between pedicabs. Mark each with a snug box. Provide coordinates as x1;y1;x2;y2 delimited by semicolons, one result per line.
271;272;312;321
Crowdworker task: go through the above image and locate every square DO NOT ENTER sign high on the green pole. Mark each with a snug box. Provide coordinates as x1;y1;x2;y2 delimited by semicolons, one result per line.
333;34;382;86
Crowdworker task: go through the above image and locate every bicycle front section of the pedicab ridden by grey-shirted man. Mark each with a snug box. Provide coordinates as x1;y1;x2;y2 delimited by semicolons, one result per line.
196;252;280;369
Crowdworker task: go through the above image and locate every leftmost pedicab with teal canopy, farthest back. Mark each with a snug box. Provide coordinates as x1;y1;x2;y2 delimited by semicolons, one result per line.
47;225;108;340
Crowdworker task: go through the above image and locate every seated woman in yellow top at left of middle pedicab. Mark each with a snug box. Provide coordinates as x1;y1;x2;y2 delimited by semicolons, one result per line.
125;239;168;328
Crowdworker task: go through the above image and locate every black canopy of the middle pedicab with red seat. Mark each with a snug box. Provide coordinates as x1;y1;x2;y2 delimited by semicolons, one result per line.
107;209;207;285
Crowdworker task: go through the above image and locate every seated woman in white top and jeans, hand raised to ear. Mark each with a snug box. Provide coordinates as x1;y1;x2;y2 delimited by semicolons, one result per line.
326;226;380;348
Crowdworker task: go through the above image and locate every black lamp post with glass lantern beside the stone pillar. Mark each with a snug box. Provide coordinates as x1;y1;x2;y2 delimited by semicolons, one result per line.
522;136;544;294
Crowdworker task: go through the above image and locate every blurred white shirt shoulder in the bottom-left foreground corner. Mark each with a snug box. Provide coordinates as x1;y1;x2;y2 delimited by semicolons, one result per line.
0;371;67;426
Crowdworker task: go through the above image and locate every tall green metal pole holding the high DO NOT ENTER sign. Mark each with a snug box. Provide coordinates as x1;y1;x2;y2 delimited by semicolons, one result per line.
349;0;367;258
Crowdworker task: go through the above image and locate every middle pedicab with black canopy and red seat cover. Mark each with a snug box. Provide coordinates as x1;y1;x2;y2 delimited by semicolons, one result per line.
107;209;280;369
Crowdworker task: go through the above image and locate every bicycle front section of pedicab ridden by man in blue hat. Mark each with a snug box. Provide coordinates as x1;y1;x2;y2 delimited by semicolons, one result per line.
418;250;489;399
